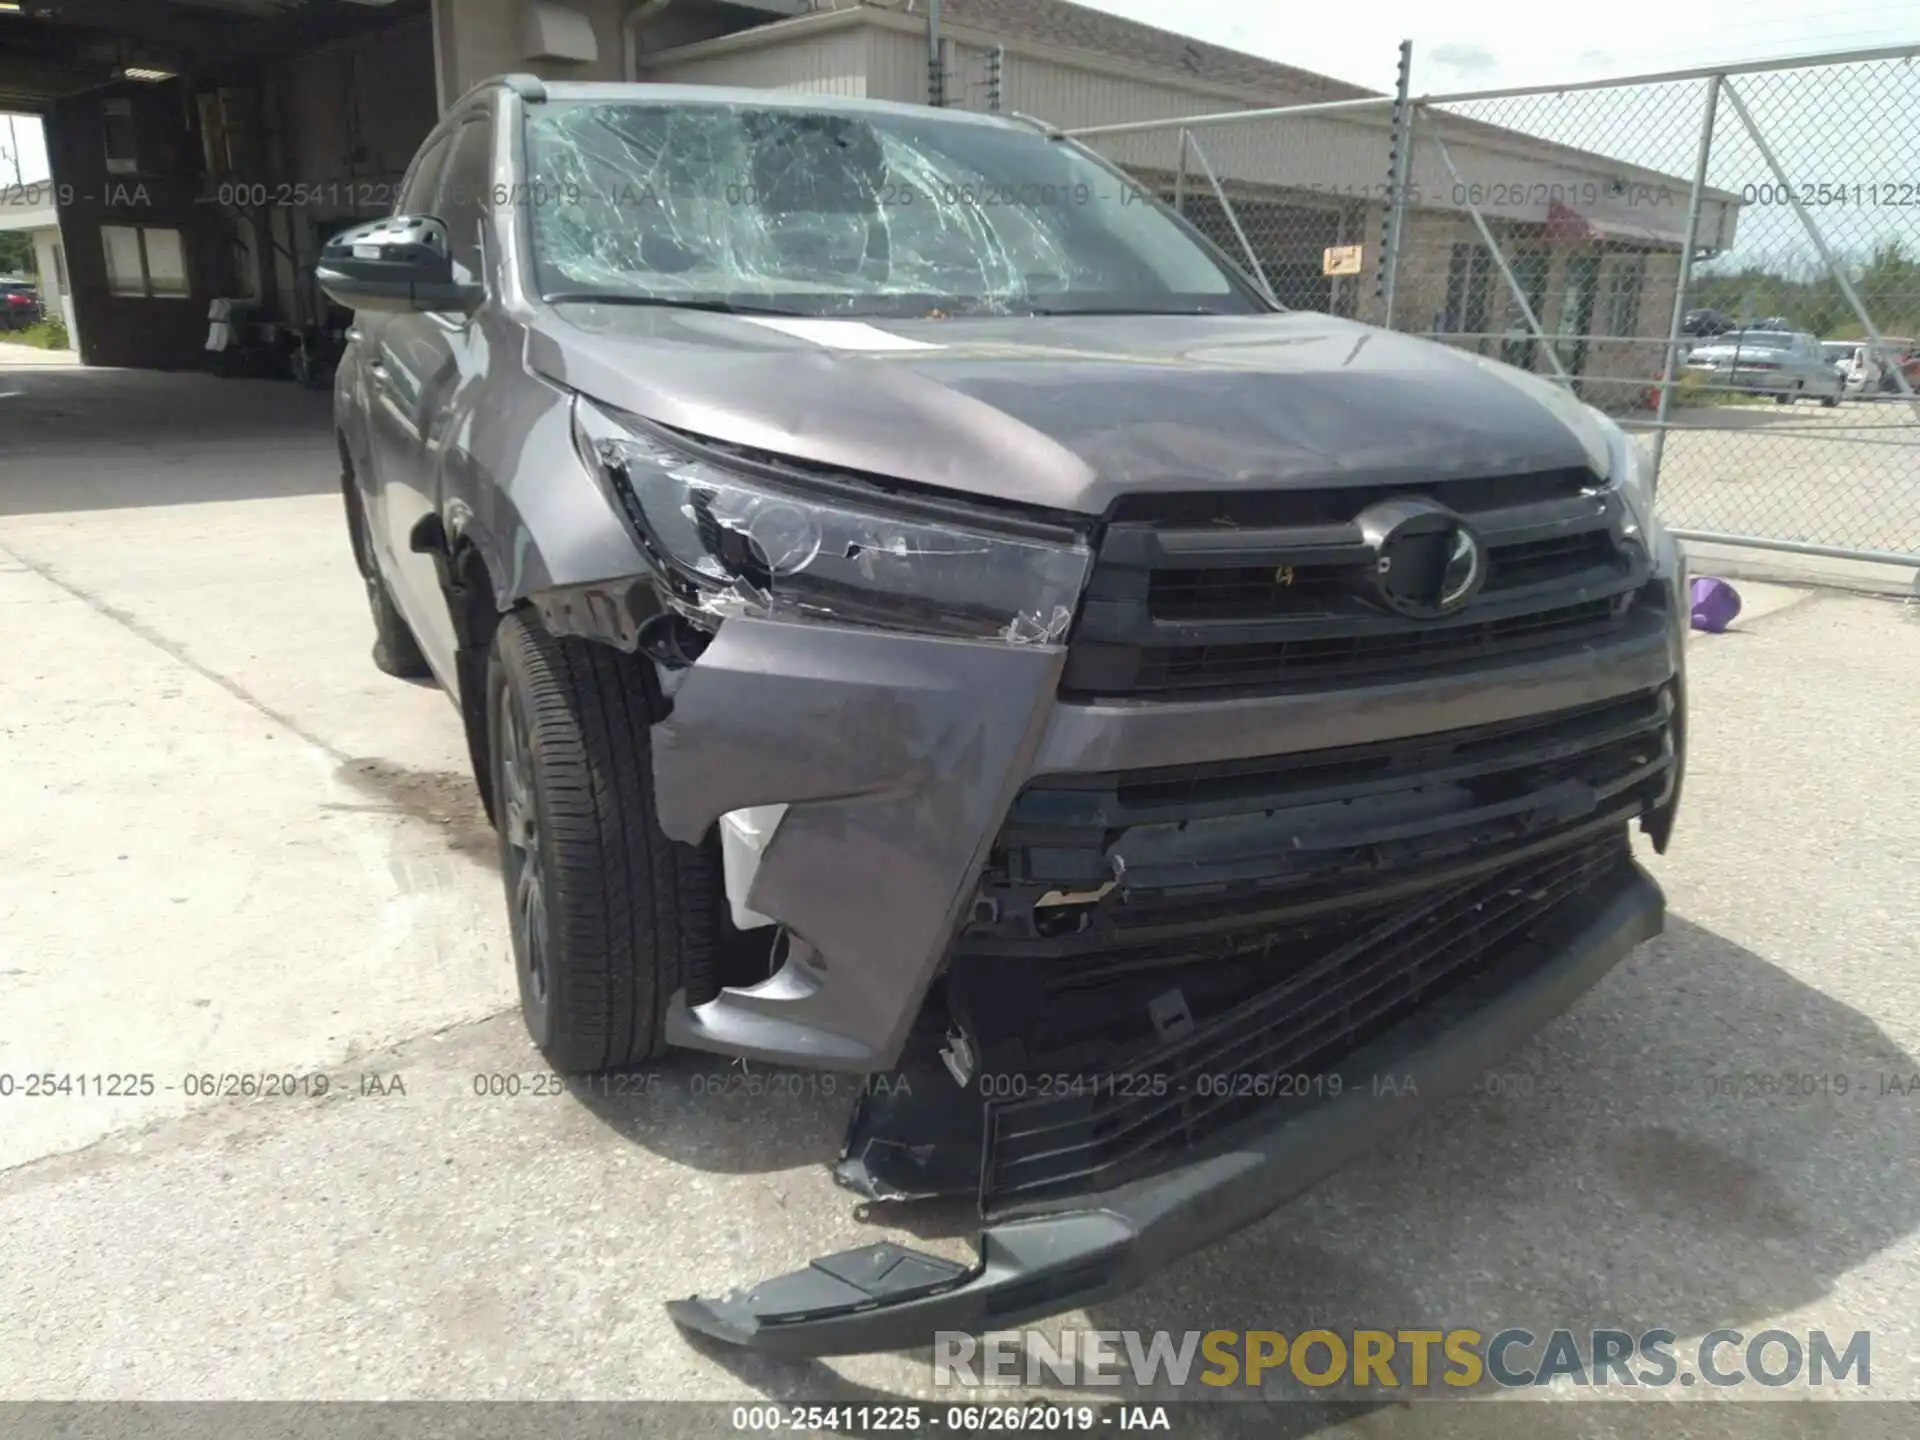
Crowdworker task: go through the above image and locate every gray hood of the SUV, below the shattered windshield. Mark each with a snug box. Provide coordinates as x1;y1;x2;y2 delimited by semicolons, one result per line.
528;303;1607;515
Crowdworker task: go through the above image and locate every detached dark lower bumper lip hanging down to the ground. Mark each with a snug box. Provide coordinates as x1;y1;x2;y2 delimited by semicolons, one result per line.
668;864;1665;1357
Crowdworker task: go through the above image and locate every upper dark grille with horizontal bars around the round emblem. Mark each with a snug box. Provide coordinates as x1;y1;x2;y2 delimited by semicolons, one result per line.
1062;470;1649;699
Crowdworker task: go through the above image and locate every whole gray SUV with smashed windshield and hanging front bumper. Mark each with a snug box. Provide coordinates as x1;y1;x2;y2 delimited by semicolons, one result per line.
319;77;1686;1356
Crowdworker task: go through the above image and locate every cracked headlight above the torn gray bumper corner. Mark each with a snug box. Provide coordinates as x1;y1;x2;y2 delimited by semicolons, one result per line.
574;397;1089;645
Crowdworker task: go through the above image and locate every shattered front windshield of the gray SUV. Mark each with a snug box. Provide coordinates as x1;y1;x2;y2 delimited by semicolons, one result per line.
526;102;1261;315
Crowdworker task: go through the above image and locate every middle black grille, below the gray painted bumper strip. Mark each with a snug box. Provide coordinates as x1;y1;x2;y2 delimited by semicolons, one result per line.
956;689;1674;956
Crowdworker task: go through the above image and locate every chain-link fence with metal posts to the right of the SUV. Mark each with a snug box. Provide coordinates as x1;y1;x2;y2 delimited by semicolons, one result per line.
1075;46;1920;564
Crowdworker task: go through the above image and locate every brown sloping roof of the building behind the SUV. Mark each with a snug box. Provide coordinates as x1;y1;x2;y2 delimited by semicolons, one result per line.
860;0;1380;100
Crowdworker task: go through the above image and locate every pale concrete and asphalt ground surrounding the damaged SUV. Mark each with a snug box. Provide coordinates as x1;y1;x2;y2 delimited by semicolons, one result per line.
0;347;1920;1436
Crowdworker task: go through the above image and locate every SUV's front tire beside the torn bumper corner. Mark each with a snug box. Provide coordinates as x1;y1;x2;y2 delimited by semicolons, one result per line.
488;611;724;1073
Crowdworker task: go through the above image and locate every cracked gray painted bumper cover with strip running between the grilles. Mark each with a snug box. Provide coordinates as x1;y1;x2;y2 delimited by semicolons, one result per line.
653;599;1684;1073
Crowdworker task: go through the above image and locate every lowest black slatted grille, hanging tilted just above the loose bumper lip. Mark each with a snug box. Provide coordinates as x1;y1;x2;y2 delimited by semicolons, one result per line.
981;831;1630;1213
